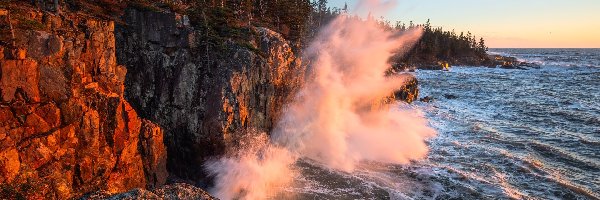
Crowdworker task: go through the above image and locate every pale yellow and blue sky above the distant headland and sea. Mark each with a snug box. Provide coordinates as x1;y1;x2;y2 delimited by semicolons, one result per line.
328;0;600;48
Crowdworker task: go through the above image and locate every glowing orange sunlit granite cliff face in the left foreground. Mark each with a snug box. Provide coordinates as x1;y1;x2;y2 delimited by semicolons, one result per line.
0;4;167;199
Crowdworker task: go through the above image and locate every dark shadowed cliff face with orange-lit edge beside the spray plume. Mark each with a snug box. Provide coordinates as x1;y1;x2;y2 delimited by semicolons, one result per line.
116;10;304;180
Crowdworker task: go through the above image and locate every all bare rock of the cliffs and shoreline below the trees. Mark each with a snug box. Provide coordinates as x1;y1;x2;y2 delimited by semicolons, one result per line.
0;1;524;199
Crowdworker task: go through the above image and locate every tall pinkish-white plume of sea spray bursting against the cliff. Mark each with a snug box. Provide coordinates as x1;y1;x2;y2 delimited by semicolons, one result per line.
206;0;435;199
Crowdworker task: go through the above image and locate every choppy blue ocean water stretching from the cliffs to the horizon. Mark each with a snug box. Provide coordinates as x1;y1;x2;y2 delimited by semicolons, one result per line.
277;49;600;199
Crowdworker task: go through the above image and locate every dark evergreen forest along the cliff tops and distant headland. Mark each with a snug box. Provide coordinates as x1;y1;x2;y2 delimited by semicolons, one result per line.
19;0;505;70
